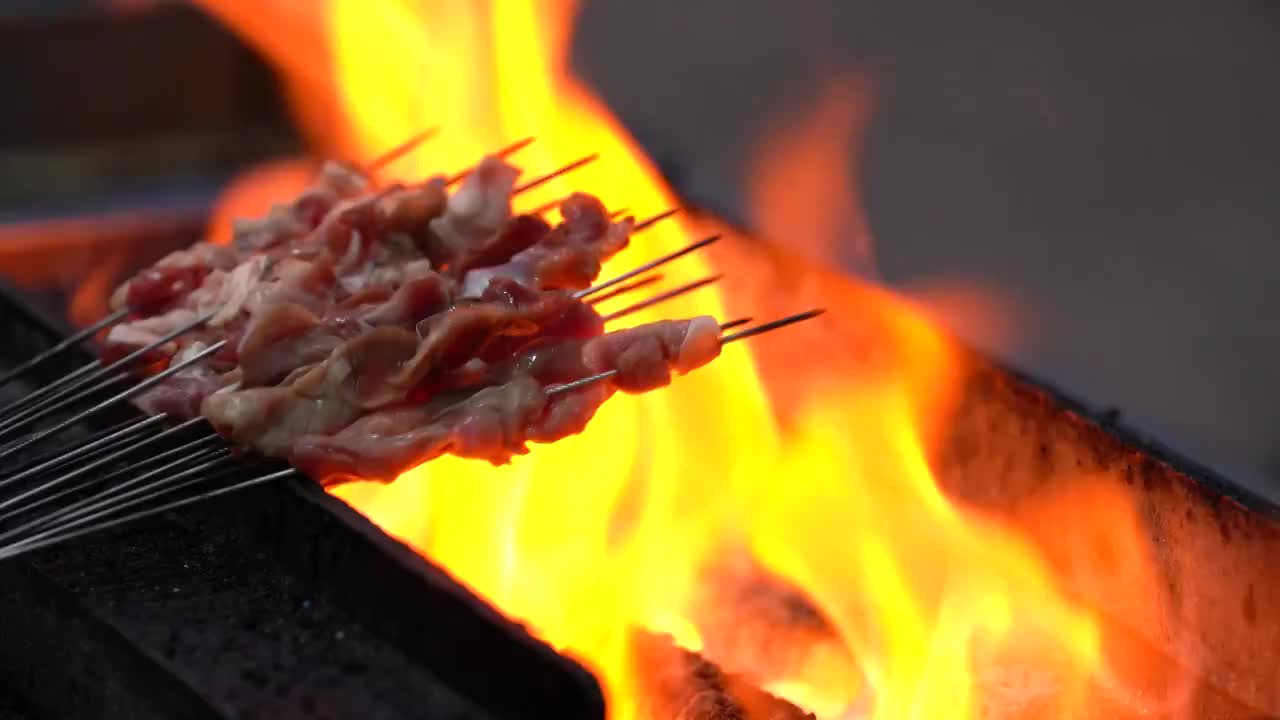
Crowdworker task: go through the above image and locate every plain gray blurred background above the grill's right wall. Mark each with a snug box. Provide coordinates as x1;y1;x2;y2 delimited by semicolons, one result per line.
576;0;1280;496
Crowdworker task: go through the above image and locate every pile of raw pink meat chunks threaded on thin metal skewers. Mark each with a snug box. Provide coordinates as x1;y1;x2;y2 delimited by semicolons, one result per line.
104;146;808;483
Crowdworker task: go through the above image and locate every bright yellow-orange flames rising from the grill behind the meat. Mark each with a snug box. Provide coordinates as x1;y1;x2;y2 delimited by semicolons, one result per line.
192;0;1131;720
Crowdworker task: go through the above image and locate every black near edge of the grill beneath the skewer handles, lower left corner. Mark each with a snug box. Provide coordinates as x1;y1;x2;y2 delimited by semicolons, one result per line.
0;281;603;719
